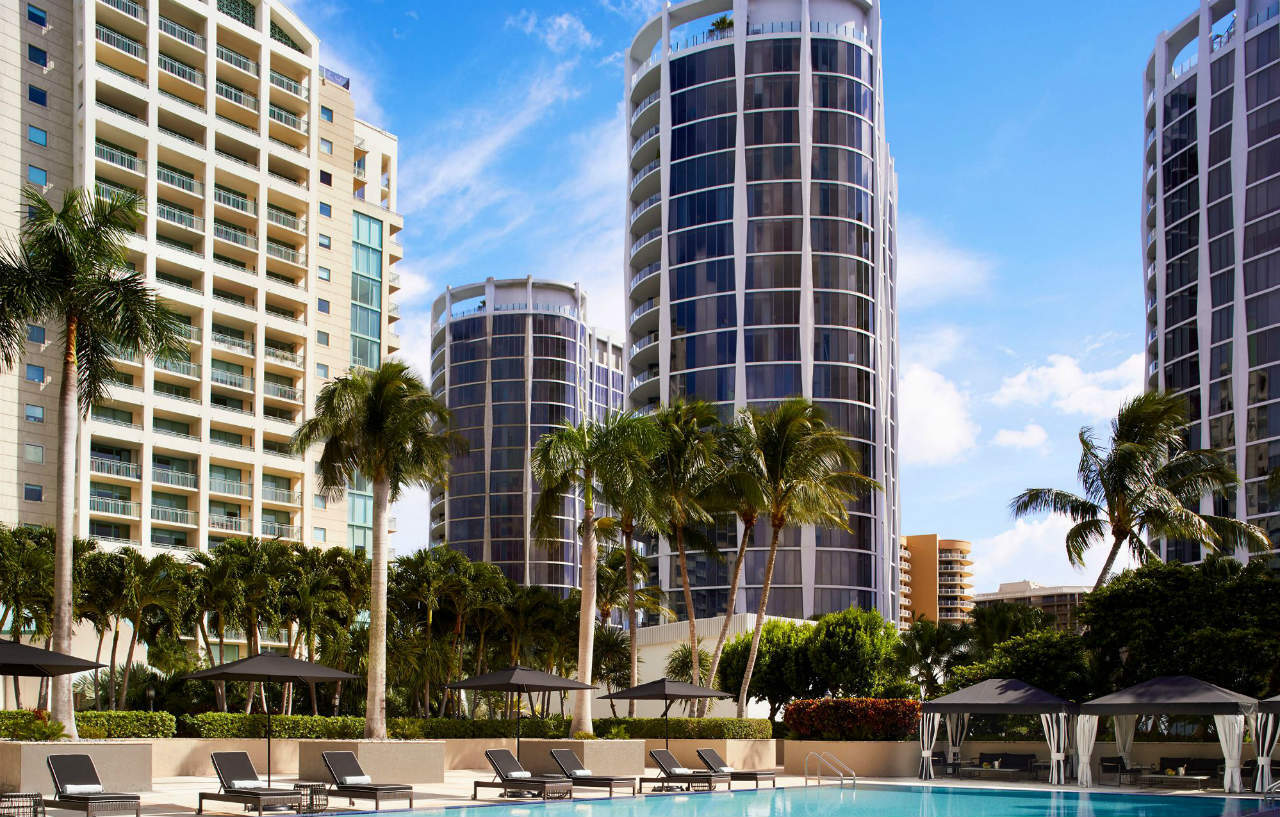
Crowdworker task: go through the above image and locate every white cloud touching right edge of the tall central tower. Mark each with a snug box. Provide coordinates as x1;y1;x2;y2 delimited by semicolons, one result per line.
899;364;982;465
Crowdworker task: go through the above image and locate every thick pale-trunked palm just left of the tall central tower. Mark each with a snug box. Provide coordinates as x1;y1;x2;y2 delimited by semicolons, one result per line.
530;412;649;734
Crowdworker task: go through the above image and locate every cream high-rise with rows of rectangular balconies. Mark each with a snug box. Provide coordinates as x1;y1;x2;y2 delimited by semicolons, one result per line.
0;0;403;594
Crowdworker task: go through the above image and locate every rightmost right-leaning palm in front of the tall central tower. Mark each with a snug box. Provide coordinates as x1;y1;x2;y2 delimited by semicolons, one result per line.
737;398;879;717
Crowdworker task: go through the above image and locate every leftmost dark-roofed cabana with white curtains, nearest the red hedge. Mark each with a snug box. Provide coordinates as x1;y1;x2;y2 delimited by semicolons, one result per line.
920;677;1075;784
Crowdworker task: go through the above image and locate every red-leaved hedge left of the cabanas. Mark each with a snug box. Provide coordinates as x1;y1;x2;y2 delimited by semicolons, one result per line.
782;698;920;740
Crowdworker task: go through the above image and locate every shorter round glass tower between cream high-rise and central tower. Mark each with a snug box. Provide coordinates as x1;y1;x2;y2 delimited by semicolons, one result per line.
431;278;623;593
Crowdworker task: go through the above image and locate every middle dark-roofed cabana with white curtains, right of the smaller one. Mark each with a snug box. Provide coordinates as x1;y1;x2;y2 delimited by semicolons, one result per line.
1076;675;1261;791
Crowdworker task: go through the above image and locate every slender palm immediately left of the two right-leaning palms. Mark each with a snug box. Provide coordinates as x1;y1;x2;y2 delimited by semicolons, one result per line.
653;400;723;684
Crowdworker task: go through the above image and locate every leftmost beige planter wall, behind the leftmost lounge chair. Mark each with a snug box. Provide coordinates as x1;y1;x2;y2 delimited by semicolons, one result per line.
0;740;151;795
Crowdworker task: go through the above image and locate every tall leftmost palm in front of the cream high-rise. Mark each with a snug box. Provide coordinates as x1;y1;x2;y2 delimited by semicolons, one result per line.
0;187;186;739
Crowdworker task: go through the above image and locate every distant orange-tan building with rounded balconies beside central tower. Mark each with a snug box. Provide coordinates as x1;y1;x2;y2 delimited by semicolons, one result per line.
899;534;973;626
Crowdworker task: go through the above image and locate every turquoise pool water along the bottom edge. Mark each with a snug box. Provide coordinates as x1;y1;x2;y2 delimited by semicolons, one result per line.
401;784;1280;817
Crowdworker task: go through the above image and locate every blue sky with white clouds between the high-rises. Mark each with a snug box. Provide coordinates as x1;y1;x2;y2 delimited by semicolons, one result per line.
294;0;1193;590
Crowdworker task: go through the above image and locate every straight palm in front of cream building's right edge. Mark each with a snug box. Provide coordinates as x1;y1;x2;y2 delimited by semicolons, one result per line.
293;360;466;739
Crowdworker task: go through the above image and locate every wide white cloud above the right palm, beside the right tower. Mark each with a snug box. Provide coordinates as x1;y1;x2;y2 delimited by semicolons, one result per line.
991;353;1143;420
